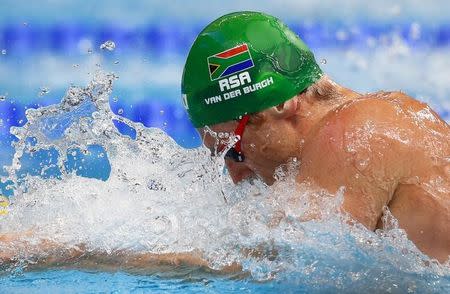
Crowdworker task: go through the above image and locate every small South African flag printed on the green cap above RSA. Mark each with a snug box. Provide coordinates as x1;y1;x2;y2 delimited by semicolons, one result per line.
208;44;254;81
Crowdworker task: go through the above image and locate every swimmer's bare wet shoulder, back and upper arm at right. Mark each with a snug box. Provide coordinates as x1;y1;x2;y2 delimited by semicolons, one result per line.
299;92;450;261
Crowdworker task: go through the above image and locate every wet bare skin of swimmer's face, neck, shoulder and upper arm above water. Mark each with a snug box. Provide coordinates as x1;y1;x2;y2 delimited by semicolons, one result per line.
200;88;450;262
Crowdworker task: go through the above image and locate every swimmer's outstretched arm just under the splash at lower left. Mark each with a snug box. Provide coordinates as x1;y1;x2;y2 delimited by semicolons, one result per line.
0;231;241;273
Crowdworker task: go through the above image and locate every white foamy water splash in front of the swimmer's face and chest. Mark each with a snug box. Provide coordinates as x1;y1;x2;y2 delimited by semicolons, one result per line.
0;72;450;292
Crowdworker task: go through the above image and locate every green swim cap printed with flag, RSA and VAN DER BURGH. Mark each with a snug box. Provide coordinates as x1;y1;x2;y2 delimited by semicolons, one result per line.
181;11;322;128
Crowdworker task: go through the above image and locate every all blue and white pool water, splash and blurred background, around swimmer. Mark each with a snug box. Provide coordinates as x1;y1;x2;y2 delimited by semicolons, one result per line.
0;1;450;293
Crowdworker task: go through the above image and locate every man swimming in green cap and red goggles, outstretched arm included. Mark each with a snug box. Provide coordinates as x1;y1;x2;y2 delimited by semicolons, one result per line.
0;12;450;270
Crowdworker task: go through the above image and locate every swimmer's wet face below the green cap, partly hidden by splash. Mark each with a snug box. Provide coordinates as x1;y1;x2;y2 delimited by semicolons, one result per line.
199;113;295;185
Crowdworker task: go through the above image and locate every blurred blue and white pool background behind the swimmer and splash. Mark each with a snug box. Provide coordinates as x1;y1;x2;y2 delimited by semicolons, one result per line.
0;0;450;173
